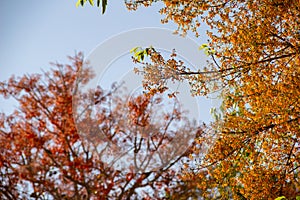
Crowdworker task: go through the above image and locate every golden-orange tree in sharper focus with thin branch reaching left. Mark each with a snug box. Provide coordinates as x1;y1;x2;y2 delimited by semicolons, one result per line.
122;0;300;199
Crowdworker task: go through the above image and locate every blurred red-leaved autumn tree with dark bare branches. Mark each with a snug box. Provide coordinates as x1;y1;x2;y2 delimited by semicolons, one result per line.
0;54;203;199
